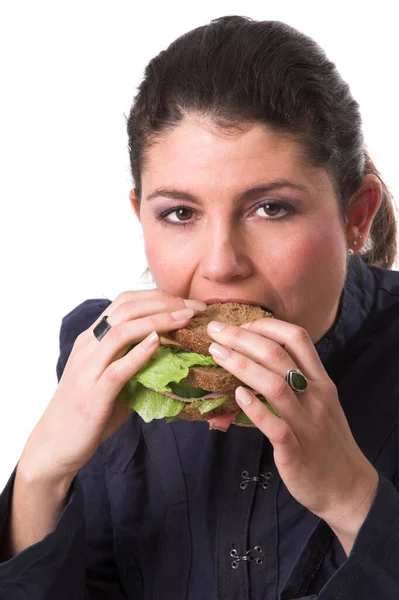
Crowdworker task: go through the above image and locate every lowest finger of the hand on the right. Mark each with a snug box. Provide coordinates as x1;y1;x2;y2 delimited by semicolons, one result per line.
235;386;299;464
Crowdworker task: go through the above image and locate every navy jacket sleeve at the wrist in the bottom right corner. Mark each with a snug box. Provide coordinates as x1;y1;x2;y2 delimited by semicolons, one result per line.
280;473;399;600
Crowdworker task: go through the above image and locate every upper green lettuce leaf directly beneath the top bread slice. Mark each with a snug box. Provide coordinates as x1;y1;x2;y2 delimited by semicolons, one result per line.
131;346;218;392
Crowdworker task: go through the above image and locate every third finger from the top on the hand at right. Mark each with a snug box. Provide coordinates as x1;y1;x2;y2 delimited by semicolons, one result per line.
209;344;306;425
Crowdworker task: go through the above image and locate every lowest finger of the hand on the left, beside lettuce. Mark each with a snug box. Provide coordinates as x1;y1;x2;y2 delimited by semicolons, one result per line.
97;331;159;404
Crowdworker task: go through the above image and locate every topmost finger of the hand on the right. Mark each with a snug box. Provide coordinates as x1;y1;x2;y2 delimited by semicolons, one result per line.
241;319;327;381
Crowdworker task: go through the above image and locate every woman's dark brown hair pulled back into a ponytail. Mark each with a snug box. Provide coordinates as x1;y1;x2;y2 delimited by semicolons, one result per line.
127;16;397;269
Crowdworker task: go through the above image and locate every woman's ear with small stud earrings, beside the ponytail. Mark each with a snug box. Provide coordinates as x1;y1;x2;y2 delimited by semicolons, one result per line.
346;175;382;252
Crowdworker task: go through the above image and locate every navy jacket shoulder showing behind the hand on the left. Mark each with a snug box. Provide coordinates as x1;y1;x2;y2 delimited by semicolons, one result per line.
57;298;111;381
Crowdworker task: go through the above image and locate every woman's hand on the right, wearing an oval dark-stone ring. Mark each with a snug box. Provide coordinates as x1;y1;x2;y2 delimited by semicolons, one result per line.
208;318;378;532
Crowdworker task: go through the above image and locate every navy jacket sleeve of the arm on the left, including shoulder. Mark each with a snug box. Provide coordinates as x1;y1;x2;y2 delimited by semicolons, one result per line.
0;300;126;600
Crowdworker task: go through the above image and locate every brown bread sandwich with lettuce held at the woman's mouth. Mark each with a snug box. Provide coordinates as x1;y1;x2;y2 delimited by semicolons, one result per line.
118;302;276;431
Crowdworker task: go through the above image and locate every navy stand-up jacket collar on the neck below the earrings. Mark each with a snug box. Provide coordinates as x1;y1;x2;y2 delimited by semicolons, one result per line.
315;255;375;363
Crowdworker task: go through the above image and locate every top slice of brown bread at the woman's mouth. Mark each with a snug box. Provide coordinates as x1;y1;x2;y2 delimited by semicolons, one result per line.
168;302;273;356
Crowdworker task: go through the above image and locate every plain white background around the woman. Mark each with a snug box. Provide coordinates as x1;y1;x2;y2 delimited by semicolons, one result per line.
0;0;399;490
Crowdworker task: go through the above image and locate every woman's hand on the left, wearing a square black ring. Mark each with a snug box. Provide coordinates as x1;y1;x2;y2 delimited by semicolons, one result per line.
18;290;206;482
